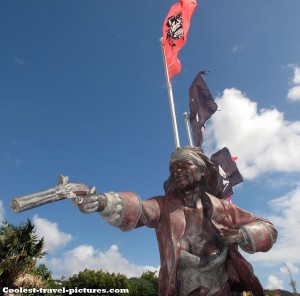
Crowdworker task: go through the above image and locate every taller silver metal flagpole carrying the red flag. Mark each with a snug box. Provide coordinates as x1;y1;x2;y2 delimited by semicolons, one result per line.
160;38;180;148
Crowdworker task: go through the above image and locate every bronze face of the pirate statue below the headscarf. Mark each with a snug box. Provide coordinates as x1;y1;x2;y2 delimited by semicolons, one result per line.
170;158;202;190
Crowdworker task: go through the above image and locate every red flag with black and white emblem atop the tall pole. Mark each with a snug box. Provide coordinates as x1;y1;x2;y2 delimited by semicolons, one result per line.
163;0;197;80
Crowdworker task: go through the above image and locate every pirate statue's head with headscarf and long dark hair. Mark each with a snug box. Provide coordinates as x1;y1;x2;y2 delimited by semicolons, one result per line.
164;146;221;198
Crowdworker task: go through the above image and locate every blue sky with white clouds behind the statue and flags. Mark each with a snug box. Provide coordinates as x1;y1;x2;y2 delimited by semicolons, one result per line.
0;0;300;290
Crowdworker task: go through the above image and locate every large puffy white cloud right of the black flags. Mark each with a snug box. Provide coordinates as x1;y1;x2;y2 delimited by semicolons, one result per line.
205;88;300;179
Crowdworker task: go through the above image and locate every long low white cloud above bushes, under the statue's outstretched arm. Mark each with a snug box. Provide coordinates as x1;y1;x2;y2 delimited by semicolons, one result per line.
45;245;158;278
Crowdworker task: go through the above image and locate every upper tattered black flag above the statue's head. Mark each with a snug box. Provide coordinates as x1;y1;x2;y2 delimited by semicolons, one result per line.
189;71;218;147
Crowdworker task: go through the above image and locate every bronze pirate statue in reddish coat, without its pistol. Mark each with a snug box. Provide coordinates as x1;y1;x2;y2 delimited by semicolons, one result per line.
79;146;277;296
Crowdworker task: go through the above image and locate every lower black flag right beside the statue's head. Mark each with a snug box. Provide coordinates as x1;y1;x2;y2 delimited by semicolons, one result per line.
210;147;243;199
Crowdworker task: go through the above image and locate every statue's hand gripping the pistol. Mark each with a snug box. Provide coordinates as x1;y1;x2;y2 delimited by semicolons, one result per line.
77;187;106;214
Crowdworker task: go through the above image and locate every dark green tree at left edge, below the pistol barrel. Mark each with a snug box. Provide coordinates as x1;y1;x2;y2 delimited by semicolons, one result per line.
0;220;46;288
